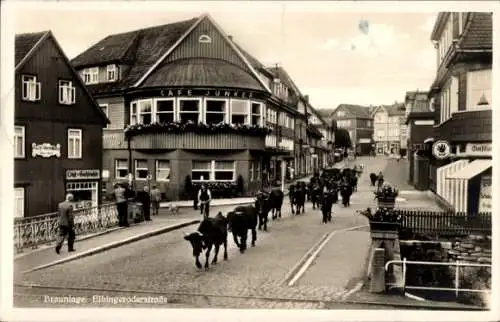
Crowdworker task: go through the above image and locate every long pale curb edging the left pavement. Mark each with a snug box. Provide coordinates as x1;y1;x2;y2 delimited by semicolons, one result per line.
22;219;200;274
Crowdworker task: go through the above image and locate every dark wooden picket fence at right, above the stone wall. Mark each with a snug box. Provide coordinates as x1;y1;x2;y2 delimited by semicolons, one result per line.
395;209;492;236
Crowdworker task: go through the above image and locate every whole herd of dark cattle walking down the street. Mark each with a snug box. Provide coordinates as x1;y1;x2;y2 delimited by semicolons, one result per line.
184;165;363;270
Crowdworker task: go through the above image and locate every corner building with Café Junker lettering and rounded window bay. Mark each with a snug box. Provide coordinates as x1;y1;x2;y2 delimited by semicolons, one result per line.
72;15;272;200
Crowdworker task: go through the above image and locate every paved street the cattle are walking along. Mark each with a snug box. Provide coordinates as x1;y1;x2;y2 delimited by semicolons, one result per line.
14;158;442;308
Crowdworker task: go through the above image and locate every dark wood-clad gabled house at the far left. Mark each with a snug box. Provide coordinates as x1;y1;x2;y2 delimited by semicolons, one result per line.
14;31;108;217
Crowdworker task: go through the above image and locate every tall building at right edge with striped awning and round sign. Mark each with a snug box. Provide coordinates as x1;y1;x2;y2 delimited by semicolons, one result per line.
429;12;494;215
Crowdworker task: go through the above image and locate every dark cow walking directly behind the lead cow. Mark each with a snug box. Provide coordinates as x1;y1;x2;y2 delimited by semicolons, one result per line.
227;205;257;253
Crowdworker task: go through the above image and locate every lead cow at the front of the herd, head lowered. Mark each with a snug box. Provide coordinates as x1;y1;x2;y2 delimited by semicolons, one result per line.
184;212;228;270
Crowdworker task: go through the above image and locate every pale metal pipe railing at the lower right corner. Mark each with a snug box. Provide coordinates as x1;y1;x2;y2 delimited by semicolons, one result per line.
385;258;491;296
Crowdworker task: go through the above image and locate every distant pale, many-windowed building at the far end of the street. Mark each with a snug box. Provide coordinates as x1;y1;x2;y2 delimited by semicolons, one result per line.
372;103;407;155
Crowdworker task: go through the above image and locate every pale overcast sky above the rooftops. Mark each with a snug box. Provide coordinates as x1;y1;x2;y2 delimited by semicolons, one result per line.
5;1;476;109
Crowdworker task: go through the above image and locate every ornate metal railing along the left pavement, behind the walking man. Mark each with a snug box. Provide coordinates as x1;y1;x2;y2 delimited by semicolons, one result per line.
14;203;118;253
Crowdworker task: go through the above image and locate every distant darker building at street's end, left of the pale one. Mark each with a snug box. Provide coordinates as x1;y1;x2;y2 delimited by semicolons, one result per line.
331;104;373;155
